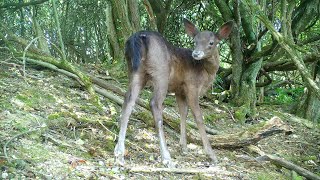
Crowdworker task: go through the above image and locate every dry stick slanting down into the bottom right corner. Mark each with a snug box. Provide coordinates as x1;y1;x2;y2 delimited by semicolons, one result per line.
248;145;320;180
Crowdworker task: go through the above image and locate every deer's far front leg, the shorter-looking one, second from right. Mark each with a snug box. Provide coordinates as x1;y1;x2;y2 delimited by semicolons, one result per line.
176;94;188;153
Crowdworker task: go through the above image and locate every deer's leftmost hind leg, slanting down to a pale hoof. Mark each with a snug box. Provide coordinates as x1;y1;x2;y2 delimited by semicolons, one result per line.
114;74;145;166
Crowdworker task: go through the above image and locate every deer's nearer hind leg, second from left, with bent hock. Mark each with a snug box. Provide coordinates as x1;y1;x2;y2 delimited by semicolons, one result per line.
150;76;175;168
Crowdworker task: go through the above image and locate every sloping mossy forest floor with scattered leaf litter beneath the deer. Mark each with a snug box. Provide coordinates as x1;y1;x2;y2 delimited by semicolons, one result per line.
0;64;320;179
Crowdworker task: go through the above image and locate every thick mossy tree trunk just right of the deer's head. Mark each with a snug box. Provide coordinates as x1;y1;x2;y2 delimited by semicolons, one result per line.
215;0;263;121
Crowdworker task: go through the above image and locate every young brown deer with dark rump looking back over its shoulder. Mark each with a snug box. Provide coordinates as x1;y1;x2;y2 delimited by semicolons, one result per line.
114;19;233;167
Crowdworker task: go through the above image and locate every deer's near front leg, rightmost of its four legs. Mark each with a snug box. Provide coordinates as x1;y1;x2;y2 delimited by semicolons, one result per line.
188;94;218;164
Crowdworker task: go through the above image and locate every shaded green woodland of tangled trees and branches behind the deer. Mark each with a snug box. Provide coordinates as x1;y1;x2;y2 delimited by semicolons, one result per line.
0;0;320;179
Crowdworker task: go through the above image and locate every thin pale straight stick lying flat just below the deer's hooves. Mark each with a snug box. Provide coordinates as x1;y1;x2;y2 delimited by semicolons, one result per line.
128;166;240;177
